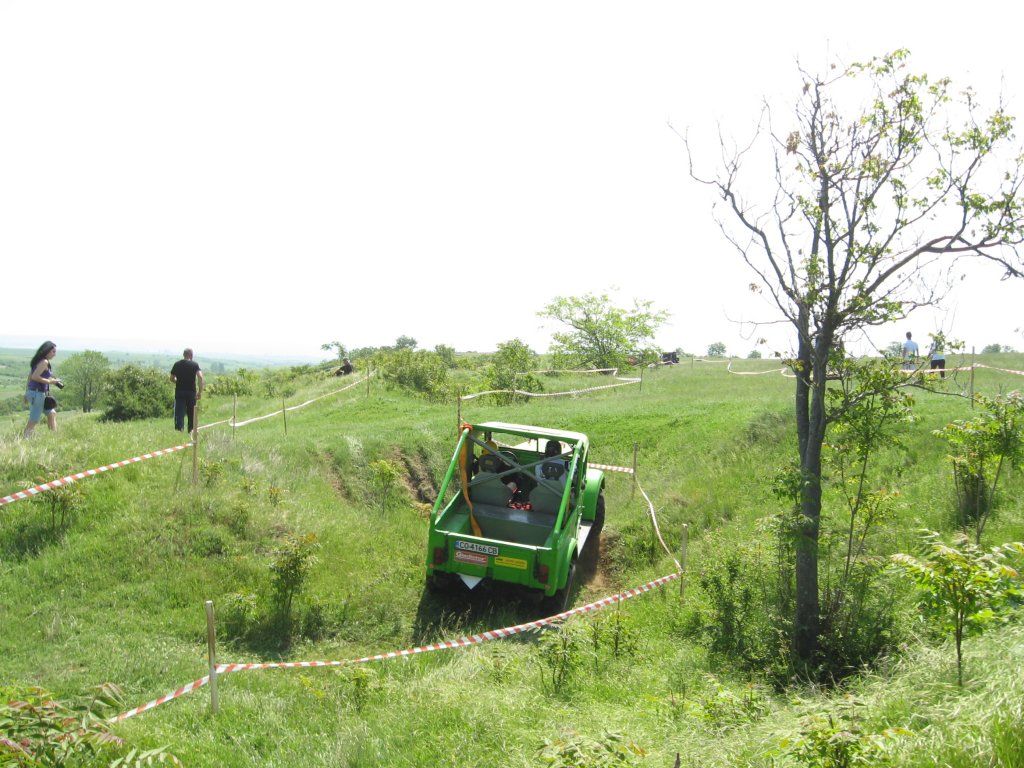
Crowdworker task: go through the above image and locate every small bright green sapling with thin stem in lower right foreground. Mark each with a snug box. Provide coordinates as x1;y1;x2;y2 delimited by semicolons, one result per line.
891;530;1024;686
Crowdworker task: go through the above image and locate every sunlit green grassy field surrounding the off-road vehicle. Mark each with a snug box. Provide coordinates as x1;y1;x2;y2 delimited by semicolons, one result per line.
0;354;1024;767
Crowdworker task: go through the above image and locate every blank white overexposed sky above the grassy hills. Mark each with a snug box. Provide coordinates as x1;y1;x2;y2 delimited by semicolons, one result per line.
0;0;1024;359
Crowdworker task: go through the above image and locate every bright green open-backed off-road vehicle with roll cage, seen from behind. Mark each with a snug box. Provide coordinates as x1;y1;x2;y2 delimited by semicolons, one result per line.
427;422;604;612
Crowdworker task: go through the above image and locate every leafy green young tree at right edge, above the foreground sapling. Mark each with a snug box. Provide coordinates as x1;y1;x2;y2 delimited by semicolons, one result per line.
935;391;1024;544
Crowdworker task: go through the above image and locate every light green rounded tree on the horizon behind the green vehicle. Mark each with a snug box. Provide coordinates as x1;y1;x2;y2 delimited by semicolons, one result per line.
538;294;669;368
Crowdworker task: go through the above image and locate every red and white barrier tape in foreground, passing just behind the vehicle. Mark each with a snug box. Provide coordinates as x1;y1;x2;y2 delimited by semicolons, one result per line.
108;572;680;723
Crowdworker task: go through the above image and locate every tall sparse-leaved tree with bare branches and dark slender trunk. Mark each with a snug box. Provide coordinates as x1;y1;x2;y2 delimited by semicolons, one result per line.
684;50;1024;663
